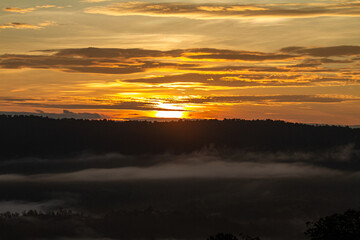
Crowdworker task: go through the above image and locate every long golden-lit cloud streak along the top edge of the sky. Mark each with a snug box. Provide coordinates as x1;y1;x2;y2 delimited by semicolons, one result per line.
85;1;360;19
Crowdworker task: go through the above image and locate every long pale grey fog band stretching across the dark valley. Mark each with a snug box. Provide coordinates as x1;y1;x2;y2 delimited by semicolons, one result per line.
0;160;343;182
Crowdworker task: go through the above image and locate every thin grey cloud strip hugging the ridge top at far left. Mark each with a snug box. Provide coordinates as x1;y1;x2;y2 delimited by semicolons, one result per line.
0;110;107;119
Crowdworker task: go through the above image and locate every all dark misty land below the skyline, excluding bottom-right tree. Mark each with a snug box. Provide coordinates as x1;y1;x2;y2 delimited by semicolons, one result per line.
0;115;360;240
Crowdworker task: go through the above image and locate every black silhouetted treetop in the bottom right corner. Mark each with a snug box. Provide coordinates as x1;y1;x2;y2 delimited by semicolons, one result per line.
305;210;360;240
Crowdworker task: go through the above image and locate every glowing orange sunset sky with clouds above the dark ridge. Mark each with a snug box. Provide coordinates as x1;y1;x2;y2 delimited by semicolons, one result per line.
0;0;360;125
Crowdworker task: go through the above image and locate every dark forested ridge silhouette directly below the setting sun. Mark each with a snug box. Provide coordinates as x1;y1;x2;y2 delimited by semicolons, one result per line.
0;115;360;159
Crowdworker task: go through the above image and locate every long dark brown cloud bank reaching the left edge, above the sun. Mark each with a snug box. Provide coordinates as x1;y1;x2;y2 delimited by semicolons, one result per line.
0;48;198;74
